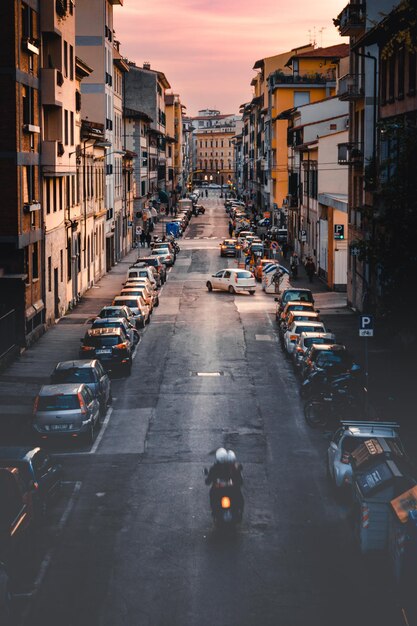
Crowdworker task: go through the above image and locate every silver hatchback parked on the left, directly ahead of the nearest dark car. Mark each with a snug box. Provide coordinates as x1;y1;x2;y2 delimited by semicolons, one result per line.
32;383;100;444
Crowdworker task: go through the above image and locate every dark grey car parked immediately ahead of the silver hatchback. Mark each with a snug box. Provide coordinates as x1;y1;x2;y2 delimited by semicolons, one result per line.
51;360;111;415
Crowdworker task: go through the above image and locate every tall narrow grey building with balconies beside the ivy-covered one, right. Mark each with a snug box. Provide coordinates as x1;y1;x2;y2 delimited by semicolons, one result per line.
334;0;397;311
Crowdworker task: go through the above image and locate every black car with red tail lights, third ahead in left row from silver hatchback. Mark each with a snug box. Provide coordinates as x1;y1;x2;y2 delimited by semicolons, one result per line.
80;328;133;375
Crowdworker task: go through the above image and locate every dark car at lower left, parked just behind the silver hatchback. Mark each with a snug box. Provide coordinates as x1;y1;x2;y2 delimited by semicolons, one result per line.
0;446;62;515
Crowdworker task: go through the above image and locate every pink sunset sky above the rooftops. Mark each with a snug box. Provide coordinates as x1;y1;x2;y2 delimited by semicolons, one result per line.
114;0;349;115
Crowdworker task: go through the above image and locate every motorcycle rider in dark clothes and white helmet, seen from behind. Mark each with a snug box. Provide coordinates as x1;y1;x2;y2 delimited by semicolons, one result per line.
205;448;243;513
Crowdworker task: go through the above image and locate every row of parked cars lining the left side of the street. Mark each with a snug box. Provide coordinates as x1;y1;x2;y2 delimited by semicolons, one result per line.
0;206;192;584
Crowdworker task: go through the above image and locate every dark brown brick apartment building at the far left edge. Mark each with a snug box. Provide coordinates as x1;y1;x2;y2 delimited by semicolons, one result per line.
0;0;43;358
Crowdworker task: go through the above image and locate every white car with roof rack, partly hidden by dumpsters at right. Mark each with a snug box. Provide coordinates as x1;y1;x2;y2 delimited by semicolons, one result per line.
327;421;404;488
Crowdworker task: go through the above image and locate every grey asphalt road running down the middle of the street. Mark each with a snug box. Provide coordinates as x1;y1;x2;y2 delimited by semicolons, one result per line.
4;195;405;626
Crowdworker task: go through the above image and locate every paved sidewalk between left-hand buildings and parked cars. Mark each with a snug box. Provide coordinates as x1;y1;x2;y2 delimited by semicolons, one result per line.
0;249;138;426
